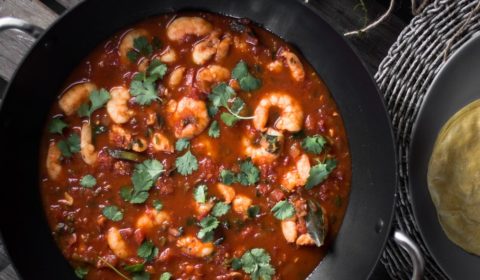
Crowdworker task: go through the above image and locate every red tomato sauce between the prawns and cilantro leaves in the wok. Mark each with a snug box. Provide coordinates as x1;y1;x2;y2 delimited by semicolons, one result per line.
40;13;351;279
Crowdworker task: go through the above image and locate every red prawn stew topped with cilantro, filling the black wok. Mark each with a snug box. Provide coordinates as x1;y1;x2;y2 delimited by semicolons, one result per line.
40;12;351;280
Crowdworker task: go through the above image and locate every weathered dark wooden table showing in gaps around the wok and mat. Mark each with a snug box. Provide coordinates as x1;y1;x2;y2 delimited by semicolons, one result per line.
0;0;411;280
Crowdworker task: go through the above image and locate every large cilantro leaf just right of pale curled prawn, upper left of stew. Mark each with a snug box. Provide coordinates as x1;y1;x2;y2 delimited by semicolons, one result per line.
130;73;160;106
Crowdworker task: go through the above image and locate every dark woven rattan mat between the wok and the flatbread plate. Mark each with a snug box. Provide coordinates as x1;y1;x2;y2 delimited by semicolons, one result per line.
375;0;480;279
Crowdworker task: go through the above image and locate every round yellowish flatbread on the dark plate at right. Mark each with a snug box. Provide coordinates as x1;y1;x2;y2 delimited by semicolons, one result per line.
427;100;480;255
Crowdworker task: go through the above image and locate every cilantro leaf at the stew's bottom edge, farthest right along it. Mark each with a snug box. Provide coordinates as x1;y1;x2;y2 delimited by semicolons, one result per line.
241;248;275;280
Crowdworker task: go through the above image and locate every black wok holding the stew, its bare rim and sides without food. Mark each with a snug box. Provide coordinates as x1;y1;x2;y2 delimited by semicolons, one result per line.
0;0;420;280
